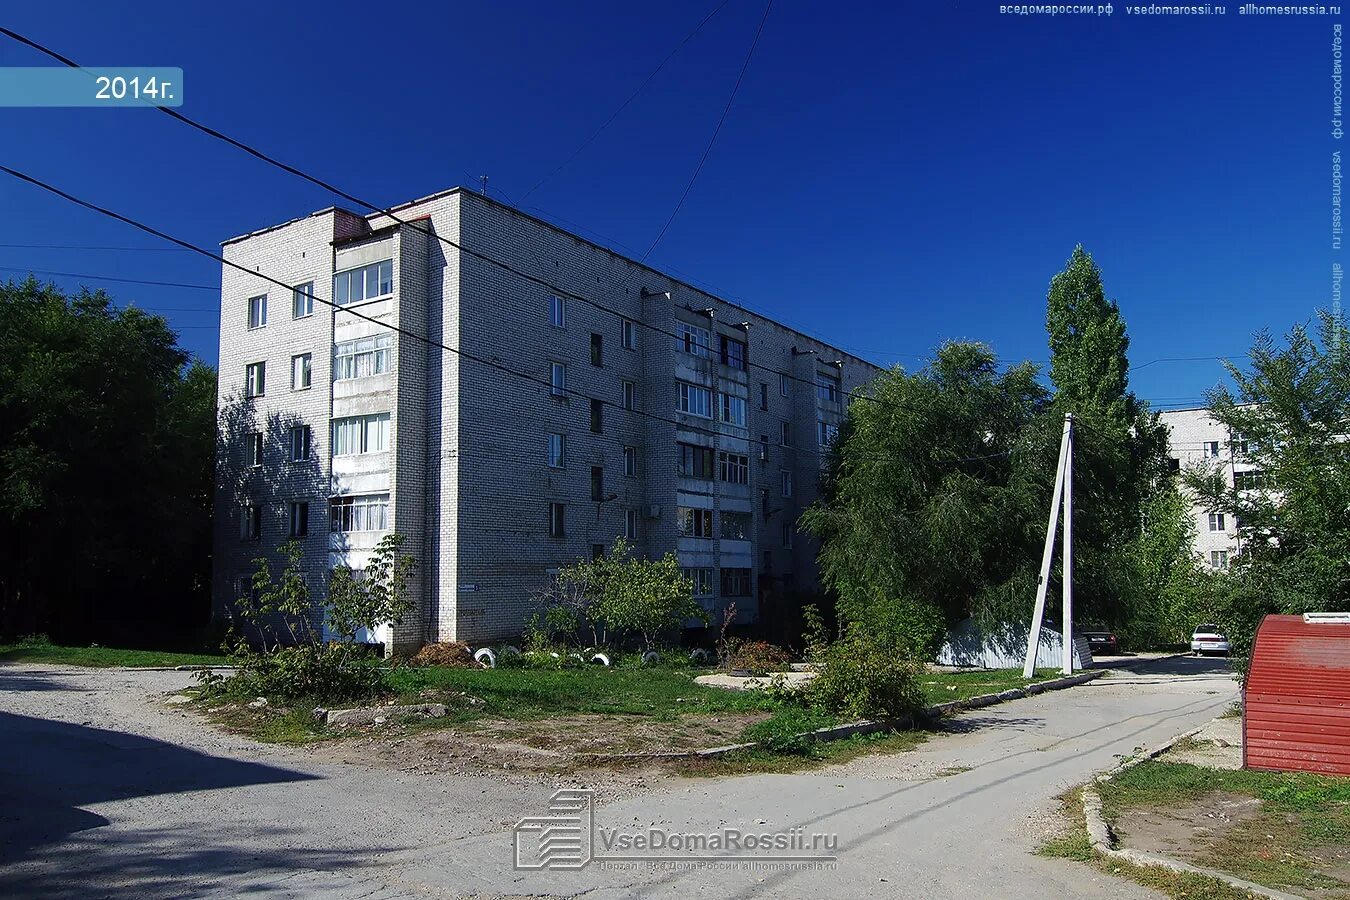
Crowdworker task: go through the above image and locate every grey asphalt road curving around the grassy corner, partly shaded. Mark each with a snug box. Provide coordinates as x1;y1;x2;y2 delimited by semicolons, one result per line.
0;657;1237;899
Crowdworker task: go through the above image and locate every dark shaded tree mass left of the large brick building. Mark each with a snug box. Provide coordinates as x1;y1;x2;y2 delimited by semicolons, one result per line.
0;278;216;640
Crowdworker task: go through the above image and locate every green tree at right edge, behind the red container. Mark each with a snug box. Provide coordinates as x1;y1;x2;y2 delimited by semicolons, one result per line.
1185;312;1350;663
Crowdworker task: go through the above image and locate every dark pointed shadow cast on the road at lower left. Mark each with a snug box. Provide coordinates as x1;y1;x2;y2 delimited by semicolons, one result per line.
0;712;316;874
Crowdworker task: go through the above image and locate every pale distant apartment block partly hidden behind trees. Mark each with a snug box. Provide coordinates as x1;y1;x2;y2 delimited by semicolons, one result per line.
1161;409;1266;569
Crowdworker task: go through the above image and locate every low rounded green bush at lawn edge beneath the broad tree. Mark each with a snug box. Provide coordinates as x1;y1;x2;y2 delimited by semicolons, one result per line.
807;631;926;719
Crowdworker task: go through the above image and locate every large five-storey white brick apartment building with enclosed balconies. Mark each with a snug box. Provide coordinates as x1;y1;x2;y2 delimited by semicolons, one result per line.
213;189;878;646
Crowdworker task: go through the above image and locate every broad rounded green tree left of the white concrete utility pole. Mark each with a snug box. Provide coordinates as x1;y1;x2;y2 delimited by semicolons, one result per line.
802;343;1058;656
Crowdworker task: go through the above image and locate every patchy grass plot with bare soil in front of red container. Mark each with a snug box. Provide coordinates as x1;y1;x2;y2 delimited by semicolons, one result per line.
1100;761;1350;896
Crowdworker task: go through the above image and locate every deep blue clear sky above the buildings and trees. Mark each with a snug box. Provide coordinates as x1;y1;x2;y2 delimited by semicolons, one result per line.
0;0;1334;405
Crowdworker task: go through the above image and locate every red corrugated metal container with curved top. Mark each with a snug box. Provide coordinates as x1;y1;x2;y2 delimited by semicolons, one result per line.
1242;615;1350;775
